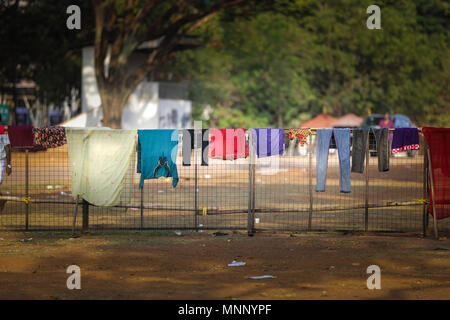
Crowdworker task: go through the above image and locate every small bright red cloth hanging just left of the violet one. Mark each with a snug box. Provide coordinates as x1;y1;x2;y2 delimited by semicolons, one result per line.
209;128;248;160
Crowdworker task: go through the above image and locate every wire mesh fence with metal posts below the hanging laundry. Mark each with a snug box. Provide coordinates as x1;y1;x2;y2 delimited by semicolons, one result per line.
0;129;450;236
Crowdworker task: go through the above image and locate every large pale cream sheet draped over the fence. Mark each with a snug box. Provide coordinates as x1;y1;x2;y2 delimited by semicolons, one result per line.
66;128;137;206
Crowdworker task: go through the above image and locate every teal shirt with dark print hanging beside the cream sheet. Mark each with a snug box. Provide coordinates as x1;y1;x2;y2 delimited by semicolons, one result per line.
137;129;178;189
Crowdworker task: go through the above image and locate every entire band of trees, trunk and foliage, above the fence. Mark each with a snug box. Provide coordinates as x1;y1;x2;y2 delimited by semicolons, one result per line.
0;0;450;127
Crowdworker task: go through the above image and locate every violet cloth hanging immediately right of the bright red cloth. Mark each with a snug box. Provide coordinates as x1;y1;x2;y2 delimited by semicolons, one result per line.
250;128;284;158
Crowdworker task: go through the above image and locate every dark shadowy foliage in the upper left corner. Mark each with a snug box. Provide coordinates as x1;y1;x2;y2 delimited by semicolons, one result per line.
0;0;93;112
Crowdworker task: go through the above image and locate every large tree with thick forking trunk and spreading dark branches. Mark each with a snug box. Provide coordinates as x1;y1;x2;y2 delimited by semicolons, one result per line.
92;0;251;128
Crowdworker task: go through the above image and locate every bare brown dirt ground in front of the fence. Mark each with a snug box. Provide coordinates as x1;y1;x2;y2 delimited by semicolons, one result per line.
0;231;450;300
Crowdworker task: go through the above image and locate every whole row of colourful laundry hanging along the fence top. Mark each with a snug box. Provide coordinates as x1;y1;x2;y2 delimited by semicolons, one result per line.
3;126;450;230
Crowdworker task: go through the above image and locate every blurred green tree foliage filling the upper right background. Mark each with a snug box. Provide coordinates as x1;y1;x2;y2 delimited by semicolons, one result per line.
172;0;450;127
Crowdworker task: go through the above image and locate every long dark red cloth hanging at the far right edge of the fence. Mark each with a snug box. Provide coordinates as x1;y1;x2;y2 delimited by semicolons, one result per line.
422;127;450;219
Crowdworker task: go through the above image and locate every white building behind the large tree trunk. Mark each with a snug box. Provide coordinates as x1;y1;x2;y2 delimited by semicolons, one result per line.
62;46;192;129
